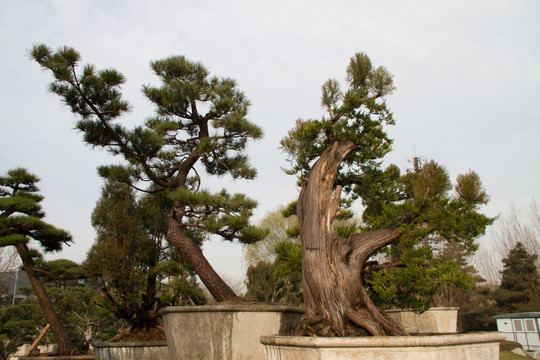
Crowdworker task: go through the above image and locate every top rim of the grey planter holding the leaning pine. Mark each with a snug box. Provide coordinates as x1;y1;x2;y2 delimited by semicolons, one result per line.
159;304;305;315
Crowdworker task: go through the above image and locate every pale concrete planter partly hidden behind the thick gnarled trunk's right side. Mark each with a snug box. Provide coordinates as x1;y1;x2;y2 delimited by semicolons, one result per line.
386;307;459;334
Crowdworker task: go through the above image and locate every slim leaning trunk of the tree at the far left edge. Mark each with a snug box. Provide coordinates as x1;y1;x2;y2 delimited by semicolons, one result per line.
15;244;78;356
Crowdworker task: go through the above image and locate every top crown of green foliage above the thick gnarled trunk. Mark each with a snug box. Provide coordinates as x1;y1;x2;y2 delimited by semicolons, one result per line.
280;53;395;197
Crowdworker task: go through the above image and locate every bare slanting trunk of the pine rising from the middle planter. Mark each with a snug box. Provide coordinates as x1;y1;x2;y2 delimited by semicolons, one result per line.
167;211;242;302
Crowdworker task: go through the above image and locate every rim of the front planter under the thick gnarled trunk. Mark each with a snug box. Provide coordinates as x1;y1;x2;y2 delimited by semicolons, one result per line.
260;331;506;348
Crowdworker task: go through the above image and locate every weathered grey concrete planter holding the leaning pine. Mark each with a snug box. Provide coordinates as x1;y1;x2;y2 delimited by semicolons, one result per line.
161;305;304;360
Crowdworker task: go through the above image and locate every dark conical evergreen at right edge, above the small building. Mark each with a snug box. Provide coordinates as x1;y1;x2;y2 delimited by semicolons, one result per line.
495;242;540;314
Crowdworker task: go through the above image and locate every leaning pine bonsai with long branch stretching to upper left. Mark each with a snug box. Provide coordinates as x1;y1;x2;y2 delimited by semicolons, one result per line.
31;45;264;302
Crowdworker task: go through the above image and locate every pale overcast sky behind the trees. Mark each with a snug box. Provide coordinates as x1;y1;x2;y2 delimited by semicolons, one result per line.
0;0;540;283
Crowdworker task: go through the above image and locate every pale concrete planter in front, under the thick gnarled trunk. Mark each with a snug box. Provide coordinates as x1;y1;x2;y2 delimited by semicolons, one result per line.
261;332;505;360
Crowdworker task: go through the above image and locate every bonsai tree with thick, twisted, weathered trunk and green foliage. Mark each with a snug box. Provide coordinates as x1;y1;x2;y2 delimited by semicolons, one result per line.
281;53;494;336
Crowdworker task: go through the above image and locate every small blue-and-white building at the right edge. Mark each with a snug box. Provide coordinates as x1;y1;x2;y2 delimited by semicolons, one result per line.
494;312;540;352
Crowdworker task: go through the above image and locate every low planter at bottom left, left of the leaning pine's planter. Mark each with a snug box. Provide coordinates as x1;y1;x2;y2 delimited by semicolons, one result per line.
93;341;169;360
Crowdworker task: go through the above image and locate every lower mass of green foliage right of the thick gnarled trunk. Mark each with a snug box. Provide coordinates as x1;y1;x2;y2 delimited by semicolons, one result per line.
364;158;494;311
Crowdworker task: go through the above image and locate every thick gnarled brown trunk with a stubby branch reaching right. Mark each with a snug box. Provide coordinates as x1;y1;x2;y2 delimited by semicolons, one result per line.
297;142;403;336
